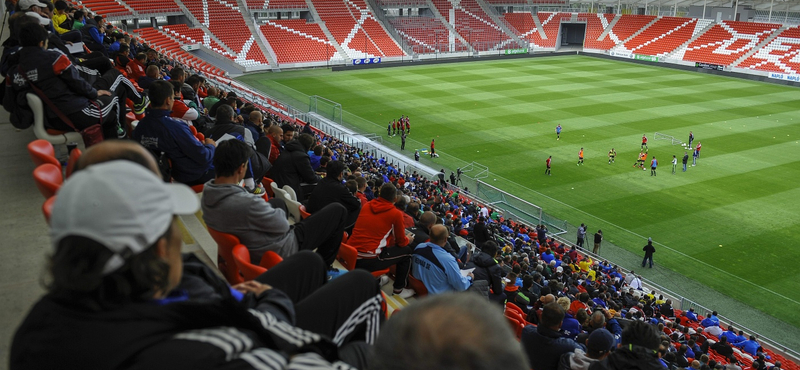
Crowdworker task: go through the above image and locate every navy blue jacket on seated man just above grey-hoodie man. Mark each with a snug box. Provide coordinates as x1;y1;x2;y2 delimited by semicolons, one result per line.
133;109;215;183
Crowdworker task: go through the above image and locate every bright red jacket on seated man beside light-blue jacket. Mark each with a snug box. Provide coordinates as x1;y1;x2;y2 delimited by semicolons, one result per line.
348;198;408;258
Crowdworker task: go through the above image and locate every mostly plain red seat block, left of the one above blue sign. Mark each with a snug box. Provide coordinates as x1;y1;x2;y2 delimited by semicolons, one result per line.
259;19;338;64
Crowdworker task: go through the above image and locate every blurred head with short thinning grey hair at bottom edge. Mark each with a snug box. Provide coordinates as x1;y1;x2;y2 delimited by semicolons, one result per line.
369;293;530;370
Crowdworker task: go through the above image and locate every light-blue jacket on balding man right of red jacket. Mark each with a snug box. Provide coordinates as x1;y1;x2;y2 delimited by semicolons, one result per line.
411;242;470;294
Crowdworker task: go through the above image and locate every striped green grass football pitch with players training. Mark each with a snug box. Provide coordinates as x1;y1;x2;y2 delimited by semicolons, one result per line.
242;56;800;327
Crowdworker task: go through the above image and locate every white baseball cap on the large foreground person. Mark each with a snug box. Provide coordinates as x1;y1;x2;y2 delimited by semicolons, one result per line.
50;160;200;275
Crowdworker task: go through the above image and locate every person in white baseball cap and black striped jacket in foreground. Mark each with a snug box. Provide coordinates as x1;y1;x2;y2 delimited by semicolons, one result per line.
9;160;380;369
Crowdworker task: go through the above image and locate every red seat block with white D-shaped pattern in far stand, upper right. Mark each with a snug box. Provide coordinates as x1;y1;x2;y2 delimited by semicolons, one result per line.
683;21;780;66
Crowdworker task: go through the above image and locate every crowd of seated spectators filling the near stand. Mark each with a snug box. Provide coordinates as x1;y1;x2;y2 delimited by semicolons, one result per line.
2;0;796;370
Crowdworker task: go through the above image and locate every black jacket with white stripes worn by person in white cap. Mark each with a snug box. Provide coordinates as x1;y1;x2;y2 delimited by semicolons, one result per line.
10;254;356;370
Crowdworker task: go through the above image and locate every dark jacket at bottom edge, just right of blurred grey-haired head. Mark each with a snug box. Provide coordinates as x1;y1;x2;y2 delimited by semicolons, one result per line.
522;325;586;370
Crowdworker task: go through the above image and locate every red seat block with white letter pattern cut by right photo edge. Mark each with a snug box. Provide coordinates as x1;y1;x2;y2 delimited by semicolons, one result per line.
737;26;800;74
